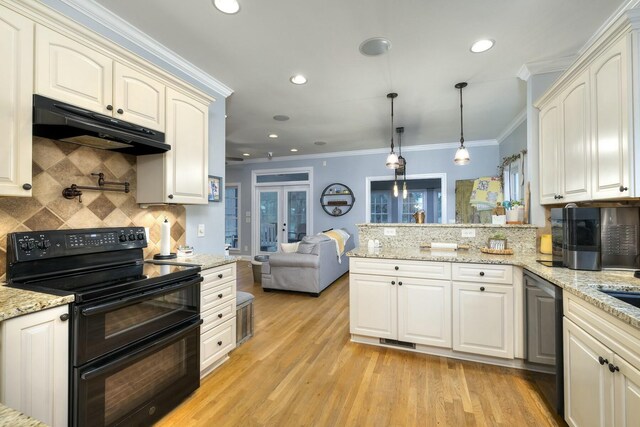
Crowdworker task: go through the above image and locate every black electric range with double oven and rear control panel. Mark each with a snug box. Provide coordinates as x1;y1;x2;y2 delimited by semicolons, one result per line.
7;227;202;426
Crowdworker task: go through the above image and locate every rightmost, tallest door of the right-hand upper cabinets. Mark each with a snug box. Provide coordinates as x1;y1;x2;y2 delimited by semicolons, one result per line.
591;36;632;199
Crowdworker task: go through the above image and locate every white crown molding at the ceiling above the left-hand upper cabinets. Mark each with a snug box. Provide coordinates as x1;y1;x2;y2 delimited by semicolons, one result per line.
58;0;233;98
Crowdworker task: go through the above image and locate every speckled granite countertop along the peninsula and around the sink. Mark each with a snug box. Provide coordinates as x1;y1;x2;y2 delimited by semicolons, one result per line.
347;247;640;329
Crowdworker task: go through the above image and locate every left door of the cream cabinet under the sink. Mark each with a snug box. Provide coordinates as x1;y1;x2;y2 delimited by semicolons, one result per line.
563;317;616;427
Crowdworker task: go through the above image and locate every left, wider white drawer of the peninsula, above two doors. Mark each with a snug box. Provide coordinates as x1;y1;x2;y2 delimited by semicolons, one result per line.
349;258;451;280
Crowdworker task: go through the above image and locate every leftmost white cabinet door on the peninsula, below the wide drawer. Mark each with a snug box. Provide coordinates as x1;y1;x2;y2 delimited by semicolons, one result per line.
349;274;398;339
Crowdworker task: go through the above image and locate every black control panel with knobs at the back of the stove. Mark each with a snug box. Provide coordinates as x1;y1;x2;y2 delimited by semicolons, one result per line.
7;227;147;262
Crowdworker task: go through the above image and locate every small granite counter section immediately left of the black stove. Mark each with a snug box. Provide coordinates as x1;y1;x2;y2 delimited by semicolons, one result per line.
0;285;73;322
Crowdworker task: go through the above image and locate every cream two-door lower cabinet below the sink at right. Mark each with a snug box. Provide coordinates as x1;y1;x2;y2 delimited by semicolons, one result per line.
563;294;640;427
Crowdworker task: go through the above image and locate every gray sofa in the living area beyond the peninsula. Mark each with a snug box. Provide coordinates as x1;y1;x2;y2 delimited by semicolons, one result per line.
262;235;354;297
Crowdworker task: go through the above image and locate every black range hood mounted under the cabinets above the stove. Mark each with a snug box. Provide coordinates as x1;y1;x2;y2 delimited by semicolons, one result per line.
33;95;171;156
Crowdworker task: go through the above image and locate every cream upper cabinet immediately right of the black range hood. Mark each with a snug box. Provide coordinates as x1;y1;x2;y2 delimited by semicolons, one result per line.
136;88;209;204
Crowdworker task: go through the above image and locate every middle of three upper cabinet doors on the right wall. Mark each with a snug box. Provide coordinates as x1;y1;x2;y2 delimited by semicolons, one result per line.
559;71;591;203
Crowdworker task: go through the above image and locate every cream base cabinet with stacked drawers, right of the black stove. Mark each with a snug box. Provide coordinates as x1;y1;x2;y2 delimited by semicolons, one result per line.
200;263;236;377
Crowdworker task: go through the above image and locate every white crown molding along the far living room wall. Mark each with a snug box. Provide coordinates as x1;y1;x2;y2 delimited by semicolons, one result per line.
227;139;498;166
